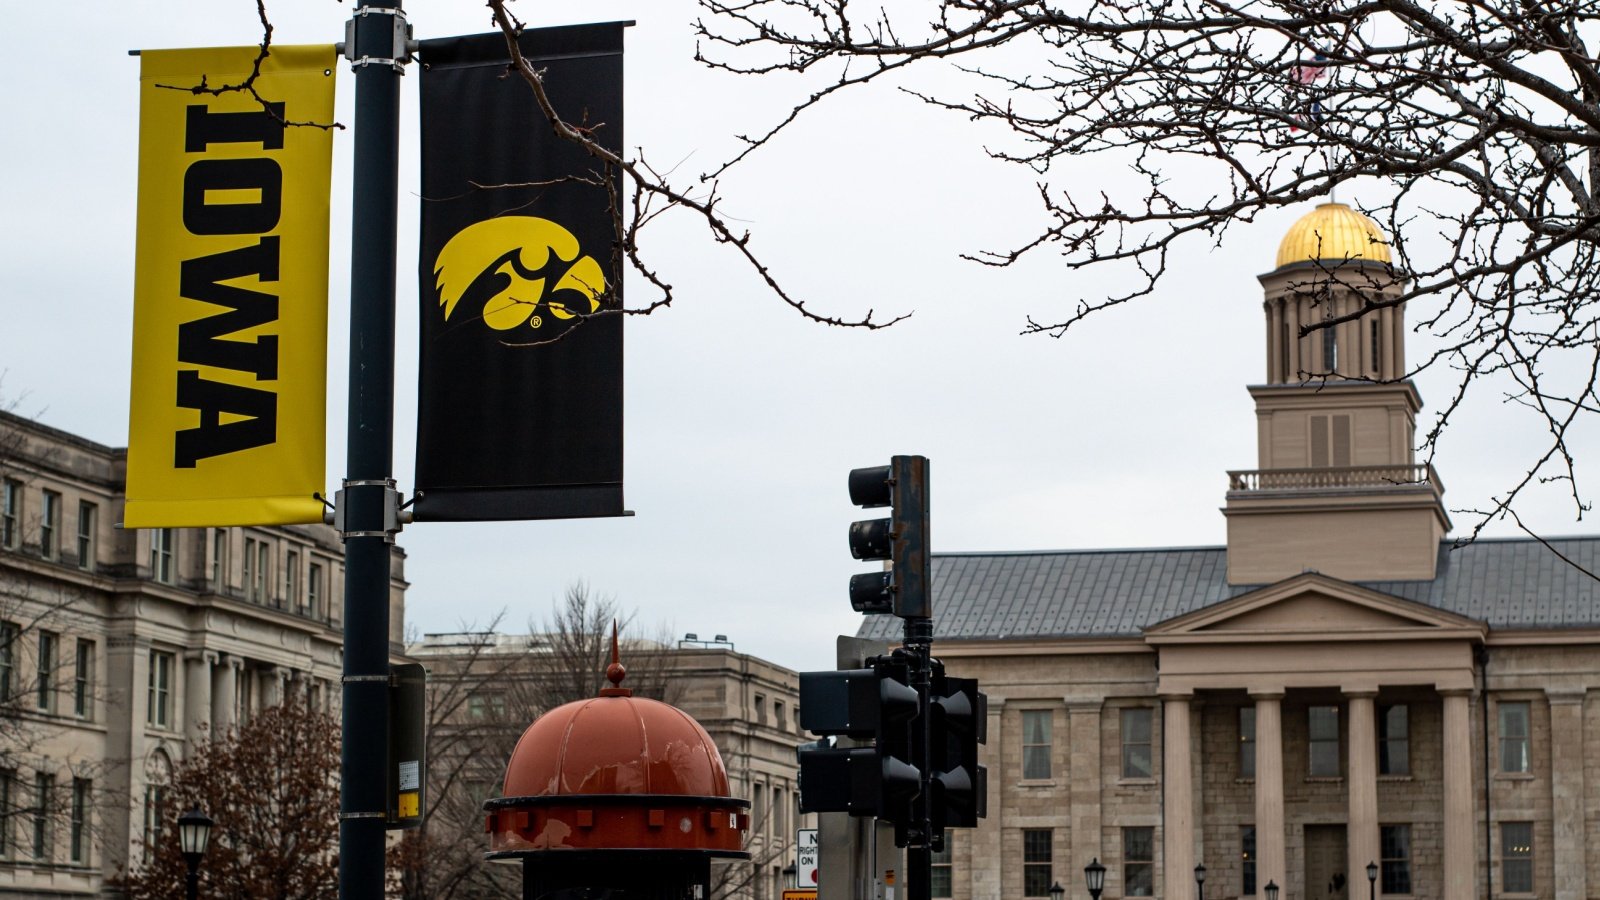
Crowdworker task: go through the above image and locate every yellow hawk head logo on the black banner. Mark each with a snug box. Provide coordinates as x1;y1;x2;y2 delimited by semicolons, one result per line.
434;216;605;331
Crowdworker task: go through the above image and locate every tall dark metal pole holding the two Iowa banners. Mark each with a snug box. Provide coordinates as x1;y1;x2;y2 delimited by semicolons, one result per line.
334;0;410;900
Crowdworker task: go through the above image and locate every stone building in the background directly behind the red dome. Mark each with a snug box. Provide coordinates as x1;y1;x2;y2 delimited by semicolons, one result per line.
408;633;814;900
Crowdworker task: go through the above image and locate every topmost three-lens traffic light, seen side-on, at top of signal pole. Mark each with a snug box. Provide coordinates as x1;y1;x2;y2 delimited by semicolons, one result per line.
850;456;933;618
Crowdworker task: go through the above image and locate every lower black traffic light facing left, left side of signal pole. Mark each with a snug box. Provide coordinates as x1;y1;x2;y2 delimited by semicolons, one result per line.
798;657;922;823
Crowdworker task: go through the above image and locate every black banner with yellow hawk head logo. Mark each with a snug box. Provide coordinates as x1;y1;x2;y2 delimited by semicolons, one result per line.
414;22;624;520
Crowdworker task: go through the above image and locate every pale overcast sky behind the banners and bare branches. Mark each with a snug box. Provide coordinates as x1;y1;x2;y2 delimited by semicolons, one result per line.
0;0;1594;669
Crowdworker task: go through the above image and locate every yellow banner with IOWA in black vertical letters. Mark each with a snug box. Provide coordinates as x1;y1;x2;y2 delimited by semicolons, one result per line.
123;45;336;528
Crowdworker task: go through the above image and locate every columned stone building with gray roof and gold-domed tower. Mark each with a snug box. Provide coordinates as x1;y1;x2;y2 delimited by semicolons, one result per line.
862;203;1600;900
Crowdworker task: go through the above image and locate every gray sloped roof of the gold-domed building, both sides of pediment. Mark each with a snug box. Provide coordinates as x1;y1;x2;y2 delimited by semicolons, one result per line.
859;536;1600;641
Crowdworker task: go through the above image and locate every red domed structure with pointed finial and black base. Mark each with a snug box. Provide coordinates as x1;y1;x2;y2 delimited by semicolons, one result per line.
483;631;750;897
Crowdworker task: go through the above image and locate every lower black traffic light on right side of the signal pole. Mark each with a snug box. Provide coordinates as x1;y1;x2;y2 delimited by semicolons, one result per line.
928;661;989;841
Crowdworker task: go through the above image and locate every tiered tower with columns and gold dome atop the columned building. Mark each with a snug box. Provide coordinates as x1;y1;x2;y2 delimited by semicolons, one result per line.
1222;203;1450;585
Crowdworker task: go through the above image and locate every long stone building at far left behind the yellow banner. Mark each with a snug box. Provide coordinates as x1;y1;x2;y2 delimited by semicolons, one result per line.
0;413;406;897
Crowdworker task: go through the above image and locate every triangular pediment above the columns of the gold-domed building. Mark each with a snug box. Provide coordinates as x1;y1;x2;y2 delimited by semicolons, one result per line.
1144;572;1488;644
